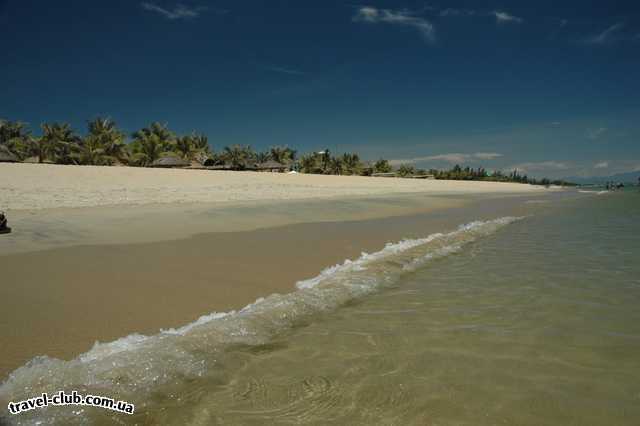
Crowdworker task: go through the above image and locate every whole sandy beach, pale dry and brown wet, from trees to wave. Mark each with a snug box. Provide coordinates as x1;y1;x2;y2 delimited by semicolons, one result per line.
0;164;549;380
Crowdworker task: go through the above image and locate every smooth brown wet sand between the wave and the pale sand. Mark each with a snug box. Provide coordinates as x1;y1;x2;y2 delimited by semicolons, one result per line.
0;191;543;377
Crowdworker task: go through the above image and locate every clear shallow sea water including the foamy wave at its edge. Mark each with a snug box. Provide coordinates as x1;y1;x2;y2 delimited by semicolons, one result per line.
0;191;640;425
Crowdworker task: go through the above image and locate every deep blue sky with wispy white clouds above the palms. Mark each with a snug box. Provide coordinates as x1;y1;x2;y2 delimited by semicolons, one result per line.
0;0;640;177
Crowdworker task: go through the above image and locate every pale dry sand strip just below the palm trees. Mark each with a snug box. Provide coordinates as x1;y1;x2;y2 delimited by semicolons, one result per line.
0;164;545;211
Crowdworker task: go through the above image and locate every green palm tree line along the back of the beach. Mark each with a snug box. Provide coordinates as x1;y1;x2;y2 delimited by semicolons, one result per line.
0;117;569;185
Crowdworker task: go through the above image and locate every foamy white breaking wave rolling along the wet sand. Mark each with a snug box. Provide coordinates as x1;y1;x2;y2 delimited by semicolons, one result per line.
0;217;521;424
